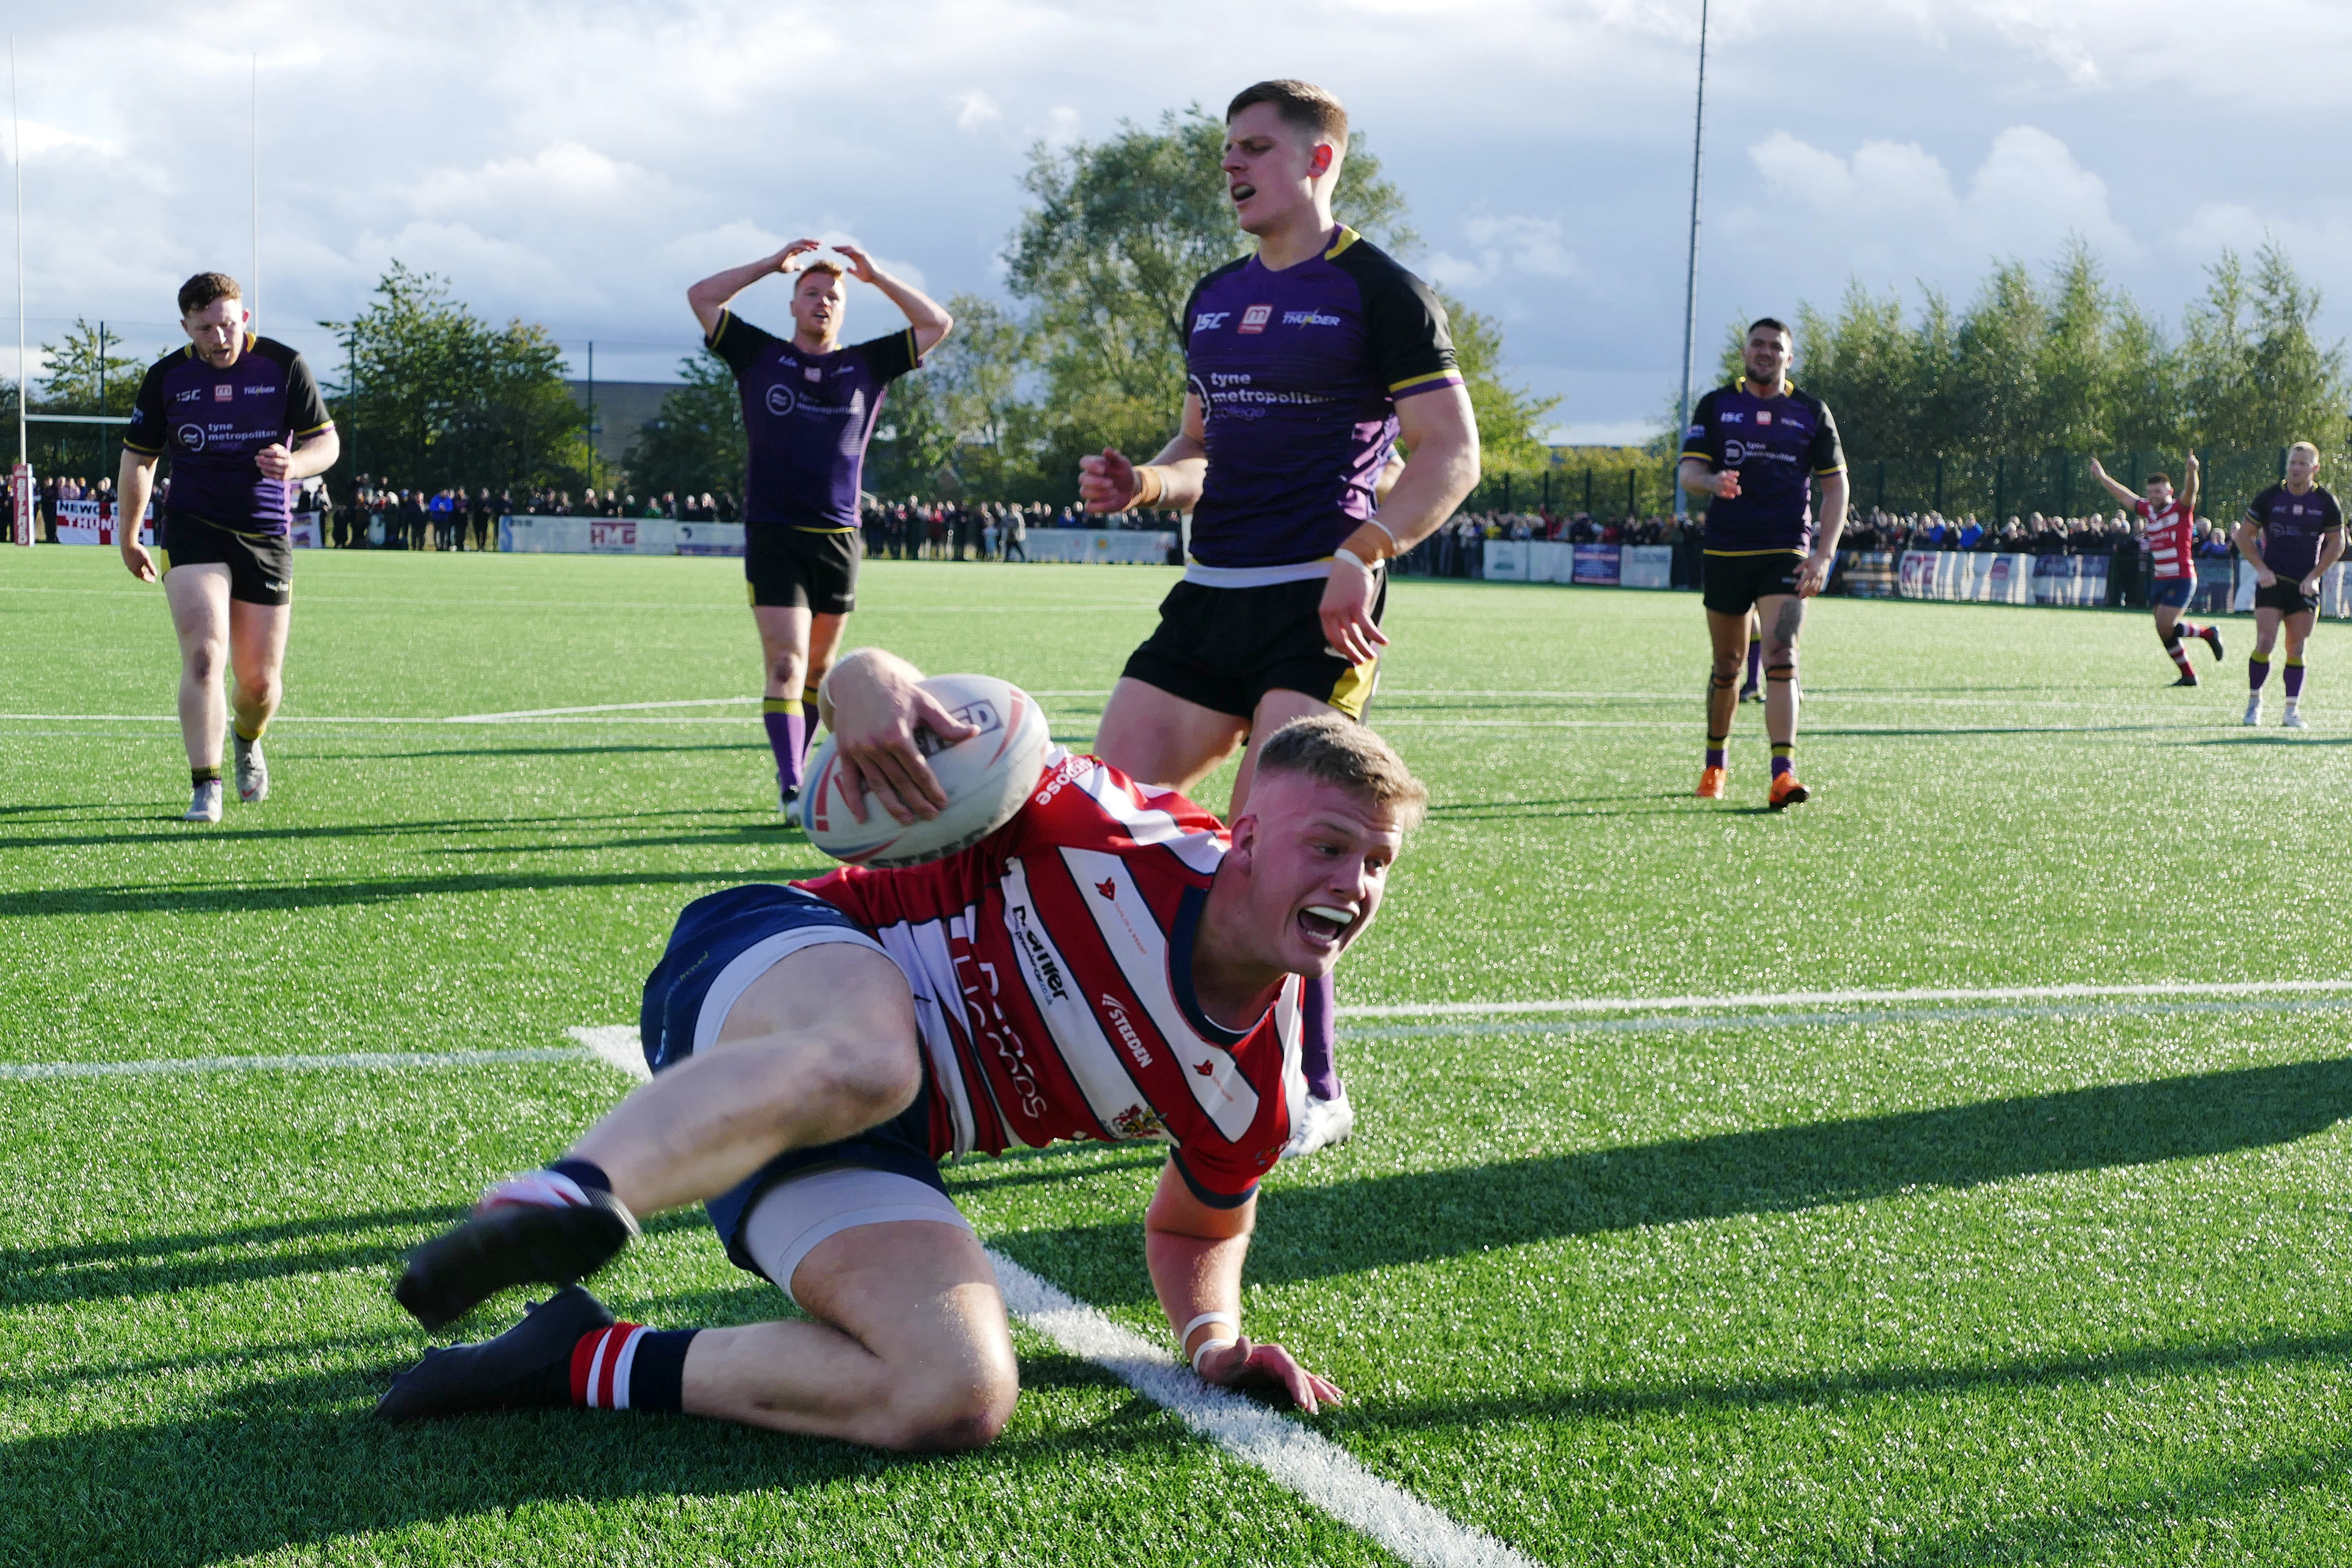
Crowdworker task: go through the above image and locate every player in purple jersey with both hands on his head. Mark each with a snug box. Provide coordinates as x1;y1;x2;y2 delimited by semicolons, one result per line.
687;239;955;811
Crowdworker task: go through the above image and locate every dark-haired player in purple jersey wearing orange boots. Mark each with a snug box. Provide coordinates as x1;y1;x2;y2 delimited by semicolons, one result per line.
1682;315;1846;811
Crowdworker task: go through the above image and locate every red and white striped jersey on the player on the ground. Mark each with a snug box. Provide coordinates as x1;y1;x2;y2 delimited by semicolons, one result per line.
795;748;1305;1206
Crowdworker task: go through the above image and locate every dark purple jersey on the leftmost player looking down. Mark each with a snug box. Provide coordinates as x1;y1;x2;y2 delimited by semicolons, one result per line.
123;334;334;533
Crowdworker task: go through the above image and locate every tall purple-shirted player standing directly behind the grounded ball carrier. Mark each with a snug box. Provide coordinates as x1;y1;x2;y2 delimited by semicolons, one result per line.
1077;80;1479;1154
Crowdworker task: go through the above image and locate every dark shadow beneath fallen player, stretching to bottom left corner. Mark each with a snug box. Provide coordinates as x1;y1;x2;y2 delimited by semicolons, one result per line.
0;1354;1193;1568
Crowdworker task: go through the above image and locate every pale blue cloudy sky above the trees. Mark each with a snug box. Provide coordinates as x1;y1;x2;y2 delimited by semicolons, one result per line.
0;0;2352;440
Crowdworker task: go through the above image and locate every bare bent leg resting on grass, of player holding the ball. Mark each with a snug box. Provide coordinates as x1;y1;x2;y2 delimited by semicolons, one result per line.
684;1220;1021;1448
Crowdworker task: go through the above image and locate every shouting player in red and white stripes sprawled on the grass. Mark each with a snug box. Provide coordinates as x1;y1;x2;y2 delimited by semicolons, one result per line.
379;649;1425;1448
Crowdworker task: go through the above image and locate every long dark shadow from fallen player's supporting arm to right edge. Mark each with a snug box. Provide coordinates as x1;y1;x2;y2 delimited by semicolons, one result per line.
995;1058;2352;1305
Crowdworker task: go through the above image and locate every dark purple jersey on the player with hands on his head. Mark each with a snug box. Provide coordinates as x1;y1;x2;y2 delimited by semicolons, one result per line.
710;311;922;531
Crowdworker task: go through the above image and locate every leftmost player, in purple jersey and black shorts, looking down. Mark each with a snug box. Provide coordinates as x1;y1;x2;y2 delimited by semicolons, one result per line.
115;273;341;823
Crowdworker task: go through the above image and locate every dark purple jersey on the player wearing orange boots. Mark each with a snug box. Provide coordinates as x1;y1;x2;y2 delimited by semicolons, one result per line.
1682;381;1846;555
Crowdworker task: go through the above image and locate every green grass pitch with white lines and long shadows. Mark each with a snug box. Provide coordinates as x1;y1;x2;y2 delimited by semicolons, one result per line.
0;550;2352;1568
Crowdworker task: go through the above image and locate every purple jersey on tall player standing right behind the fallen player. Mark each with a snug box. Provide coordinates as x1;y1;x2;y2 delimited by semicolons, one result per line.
1183;225;1463;569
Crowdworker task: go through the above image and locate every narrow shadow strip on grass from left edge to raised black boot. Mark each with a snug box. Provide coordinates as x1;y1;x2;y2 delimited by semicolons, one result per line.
0;1204;706;1307
